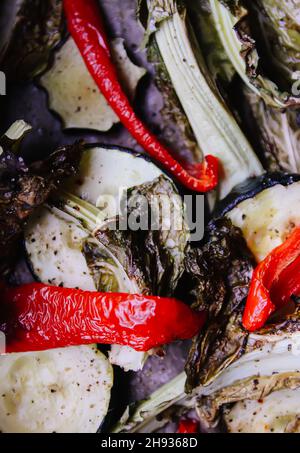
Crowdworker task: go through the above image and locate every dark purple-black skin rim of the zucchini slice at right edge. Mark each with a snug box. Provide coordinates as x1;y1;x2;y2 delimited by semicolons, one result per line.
213;172;300;218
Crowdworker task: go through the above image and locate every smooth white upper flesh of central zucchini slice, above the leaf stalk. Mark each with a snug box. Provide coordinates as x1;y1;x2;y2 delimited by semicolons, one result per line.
66;147;163;222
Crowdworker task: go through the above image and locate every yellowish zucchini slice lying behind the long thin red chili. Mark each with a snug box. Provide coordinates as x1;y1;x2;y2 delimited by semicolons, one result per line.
40;38;146;132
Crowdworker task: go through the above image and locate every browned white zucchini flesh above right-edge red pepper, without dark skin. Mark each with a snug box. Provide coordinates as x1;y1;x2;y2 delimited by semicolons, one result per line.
227;182;300;262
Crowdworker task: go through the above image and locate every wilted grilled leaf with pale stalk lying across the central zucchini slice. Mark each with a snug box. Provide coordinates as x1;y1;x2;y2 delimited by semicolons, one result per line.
58;176;189;296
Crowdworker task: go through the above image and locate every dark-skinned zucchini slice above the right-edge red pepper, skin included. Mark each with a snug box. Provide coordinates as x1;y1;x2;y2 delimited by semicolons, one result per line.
216;173;300;262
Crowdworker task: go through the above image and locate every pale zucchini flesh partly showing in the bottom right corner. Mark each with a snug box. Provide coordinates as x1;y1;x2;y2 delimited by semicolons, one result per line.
224;389;300;433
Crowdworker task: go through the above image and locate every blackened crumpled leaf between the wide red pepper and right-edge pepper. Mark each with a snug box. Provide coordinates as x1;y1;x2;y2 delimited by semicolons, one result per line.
186;218;254;391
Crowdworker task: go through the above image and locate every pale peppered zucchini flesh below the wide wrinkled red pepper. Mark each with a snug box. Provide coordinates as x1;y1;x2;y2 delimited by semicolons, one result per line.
0;346;113;433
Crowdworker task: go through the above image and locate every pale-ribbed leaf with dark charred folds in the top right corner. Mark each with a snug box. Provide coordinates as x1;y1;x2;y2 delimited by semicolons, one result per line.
210;0;300;109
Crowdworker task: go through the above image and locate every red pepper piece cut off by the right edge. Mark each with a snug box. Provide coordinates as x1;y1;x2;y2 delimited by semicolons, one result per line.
243;228;300;332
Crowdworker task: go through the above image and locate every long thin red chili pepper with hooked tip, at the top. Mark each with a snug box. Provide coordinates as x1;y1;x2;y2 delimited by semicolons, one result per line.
64;0;218;192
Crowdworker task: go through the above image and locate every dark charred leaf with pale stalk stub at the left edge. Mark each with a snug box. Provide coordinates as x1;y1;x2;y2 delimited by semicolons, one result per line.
0;122;82;273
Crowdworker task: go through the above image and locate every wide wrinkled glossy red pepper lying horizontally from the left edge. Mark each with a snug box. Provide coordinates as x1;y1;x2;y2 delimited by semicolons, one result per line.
0;284;205;353
